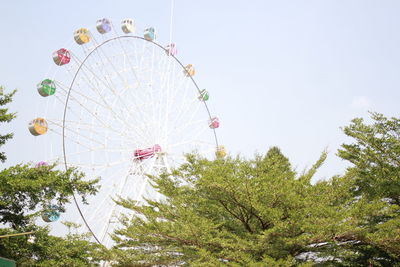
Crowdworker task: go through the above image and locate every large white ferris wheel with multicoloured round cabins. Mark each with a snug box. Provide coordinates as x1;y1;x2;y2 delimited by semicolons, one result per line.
29;19;226;246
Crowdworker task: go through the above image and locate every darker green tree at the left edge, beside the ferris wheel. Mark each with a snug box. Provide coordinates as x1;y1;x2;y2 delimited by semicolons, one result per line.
0;87;101;267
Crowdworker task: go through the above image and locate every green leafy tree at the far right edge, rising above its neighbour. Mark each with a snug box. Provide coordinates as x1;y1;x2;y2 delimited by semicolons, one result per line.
286;113;400;267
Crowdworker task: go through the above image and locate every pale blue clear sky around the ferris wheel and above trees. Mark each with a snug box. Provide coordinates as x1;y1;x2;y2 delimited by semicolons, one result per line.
0;0;400;181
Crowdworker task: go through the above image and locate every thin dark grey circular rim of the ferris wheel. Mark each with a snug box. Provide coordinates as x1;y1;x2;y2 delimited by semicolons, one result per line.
62;35;218;245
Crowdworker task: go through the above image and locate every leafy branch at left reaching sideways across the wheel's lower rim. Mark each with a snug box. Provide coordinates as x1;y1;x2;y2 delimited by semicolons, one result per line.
0;165;98;229
